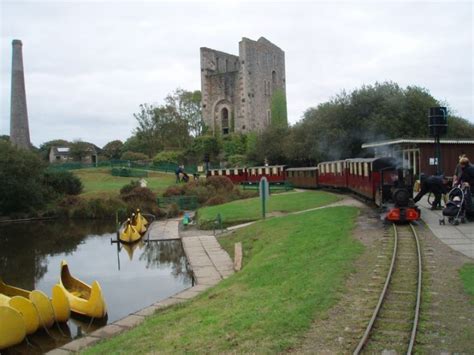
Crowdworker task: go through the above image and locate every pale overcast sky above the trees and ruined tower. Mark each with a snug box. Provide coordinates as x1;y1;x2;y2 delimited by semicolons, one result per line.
0;0;474;147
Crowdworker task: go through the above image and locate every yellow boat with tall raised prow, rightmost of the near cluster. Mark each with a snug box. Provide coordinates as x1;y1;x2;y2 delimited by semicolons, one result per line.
59;260;107;318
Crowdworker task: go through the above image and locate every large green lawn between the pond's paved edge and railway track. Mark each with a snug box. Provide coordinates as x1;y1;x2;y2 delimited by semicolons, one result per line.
85;207;363;354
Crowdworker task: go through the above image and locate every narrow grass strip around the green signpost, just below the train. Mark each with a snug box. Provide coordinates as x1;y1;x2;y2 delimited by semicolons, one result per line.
198;191;340;228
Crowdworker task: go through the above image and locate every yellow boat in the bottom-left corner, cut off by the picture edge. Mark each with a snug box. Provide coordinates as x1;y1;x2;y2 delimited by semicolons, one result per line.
0;300;27;350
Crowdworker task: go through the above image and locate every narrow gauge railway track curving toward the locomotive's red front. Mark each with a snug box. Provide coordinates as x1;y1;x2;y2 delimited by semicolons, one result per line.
354;224;422;354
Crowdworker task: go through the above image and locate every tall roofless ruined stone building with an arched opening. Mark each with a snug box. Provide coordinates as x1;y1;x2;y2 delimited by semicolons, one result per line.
201;37;286;135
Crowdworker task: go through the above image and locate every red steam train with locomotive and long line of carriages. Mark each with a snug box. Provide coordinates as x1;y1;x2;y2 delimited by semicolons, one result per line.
209;157;420;222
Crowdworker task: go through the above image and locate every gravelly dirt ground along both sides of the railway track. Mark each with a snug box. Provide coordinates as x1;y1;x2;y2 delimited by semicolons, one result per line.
294;208;474;354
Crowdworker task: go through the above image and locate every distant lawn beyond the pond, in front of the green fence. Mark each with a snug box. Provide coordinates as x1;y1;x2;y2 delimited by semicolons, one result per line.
73;168;175;198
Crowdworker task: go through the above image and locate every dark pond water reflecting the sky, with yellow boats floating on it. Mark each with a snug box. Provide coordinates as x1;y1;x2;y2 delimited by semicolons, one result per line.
0;221;192;353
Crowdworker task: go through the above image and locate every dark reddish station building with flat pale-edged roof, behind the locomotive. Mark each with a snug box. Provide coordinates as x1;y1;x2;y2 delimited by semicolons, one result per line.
362;138;474;176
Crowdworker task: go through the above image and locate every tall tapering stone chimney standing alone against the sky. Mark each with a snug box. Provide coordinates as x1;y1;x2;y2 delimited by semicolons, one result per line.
10;39;31;149
